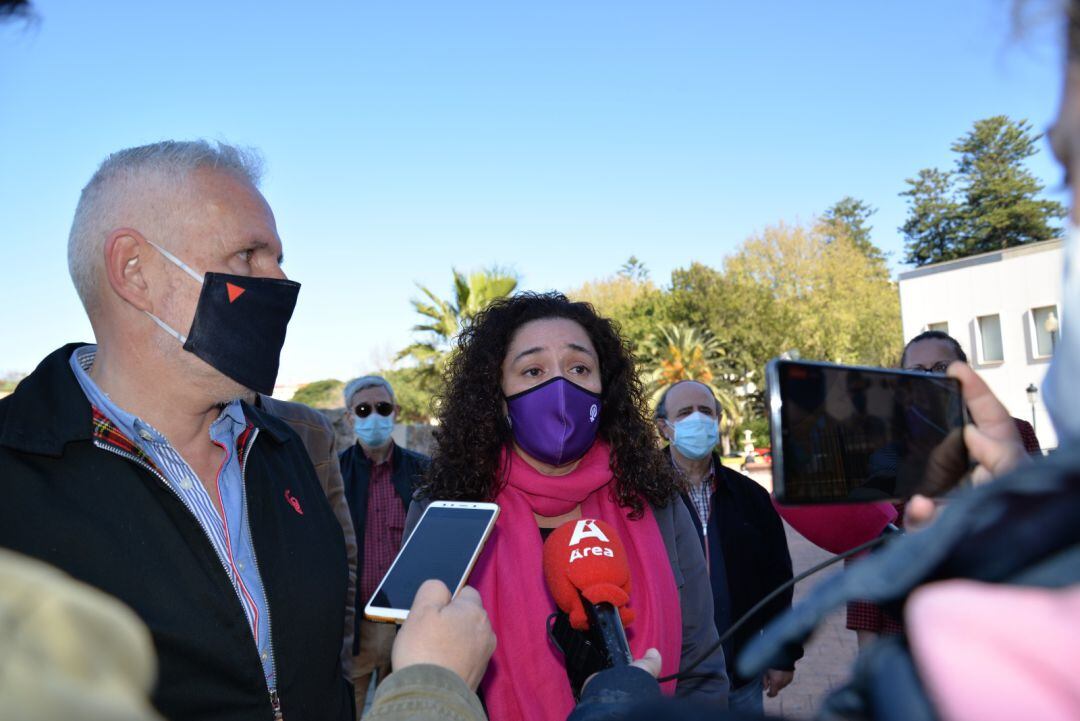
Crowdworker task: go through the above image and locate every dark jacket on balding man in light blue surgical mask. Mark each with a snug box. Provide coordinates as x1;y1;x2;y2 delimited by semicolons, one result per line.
667;449;802;689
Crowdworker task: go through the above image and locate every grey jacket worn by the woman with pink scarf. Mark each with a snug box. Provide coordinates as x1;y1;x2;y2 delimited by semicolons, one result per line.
405;496;729;707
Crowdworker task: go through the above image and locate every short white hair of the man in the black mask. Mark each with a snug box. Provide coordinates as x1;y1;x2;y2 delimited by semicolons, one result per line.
68;140;262;314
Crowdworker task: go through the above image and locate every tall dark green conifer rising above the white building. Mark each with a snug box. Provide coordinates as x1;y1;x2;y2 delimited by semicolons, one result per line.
900;115;1066;266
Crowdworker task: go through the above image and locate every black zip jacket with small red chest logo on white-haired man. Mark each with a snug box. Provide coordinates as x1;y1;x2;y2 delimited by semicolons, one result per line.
0;344;353;721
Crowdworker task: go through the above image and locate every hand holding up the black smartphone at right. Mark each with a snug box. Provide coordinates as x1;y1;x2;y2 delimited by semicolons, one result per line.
905;361;1029;529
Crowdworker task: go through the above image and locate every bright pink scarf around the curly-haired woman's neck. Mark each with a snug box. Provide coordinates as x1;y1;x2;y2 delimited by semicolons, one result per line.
470;440;683;721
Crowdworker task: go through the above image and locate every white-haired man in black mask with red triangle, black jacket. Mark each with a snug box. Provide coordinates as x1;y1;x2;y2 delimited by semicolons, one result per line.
0;141;352;721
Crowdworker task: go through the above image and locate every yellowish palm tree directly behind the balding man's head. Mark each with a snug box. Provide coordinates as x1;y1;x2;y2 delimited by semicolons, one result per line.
638;324;743;453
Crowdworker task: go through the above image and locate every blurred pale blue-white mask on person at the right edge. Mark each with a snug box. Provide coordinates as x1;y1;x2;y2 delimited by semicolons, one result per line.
1042;223;1080;447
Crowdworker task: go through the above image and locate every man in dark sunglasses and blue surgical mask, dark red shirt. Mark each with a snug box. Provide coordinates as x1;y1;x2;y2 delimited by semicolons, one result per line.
339;376;431;718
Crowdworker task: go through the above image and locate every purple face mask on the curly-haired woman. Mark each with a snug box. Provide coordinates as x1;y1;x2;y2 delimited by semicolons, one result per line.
507;376;600;466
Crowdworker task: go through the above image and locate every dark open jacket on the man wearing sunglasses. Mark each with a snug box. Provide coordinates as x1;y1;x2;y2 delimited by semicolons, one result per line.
338;443;431;655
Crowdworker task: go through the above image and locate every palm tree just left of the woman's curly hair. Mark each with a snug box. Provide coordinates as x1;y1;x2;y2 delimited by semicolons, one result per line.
397;268;517;391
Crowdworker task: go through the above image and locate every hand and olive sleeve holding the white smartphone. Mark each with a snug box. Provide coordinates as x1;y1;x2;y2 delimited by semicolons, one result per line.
364;581;495;721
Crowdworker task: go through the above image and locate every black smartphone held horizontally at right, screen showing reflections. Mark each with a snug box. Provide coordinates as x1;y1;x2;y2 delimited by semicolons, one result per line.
766;358;969;504
